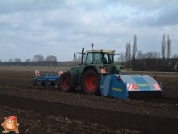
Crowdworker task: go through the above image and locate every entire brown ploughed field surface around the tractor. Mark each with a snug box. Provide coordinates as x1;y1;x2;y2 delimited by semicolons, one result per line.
0;67;178;134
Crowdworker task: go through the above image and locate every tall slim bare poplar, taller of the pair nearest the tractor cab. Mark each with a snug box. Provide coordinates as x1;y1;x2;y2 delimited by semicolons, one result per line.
132;35;137;70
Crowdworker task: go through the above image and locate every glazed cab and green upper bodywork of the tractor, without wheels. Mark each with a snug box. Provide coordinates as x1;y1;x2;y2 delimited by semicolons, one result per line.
71;48;120;74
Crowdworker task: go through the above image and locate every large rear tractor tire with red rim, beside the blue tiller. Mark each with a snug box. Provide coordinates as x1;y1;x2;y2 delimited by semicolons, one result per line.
82;69;100;95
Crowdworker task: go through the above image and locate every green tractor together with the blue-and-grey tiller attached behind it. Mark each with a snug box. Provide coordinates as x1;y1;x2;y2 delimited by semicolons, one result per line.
60;45;162;98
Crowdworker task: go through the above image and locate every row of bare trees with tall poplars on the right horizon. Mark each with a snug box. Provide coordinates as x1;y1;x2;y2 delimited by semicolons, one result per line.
118;34;178;70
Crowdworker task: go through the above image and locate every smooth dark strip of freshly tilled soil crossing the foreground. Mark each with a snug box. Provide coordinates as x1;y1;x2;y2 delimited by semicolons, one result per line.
0;95;178;133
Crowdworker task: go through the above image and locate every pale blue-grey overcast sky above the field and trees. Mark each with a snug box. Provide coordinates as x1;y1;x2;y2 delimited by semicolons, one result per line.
0;0;178;61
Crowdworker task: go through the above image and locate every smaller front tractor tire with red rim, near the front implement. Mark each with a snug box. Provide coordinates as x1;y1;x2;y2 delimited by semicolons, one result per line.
60;73;72;92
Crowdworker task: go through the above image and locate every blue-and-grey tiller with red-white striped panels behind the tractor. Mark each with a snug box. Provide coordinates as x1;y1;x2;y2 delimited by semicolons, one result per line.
100;74;162;98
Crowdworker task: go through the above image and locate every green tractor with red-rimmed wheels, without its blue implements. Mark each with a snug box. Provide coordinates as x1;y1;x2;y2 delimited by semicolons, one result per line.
60;48;120;95
